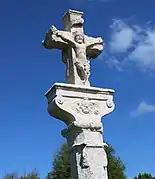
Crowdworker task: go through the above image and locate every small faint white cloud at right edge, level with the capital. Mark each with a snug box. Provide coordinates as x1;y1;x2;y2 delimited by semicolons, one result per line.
131;101;155;117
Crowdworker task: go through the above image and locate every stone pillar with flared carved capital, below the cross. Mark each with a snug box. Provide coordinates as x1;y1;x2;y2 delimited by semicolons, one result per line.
46;83;114;179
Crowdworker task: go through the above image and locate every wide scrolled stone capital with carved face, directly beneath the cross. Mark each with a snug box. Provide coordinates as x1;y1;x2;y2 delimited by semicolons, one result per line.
46;83;114;126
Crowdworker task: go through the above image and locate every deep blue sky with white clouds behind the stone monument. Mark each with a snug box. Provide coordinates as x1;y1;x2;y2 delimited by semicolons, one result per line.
0;0;155;178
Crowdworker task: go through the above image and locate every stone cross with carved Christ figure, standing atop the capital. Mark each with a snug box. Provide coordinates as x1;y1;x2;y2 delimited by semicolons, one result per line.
42;10;103;86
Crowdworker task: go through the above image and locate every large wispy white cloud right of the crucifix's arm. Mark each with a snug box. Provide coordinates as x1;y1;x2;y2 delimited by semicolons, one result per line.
106;19;155;71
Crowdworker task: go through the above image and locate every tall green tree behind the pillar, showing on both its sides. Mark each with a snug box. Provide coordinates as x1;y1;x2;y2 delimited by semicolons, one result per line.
47;143;126;179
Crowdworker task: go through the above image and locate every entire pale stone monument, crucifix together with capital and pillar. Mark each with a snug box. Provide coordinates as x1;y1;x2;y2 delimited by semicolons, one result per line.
43;10;115;179
